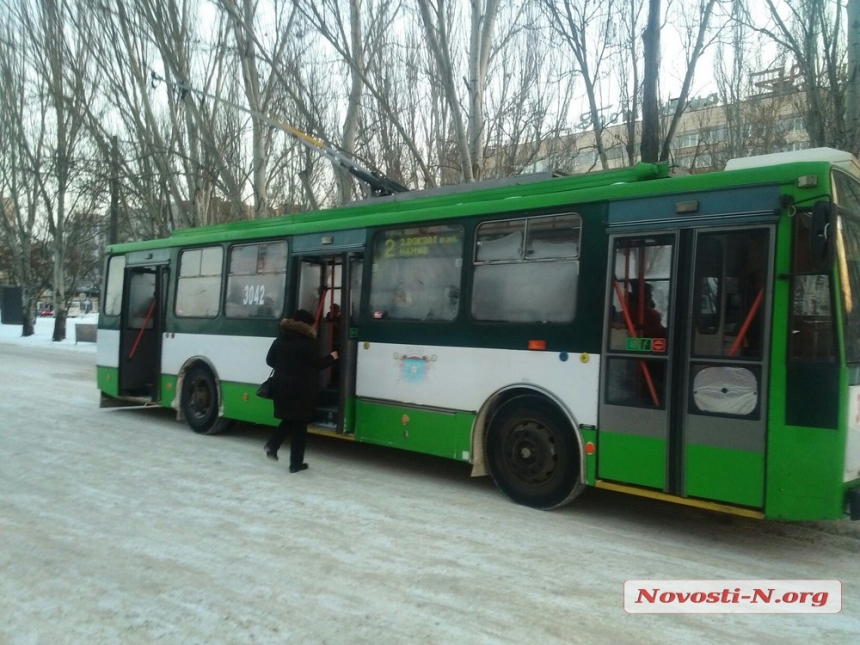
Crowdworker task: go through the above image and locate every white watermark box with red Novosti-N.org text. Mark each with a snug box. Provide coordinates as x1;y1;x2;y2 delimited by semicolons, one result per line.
624;580;842;614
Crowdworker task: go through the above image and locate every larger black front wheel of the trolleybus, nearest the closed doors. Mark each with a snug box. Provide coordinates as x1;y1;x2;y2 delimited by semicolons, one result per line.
486;396;583;510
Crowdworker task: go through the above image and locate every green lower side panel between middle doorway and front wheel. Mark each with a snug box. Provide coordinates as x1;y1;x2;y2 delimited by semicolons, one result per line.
355;399;475;461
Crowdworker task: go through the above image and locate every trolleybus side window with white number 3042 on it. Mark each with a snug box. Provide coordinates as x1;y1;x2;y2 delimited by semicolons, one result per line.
224;241;287;318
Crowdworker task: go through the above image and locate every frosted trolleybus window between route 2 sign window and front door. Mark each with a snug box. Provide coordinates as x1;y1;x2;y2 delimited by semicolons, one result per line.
471;213;582;323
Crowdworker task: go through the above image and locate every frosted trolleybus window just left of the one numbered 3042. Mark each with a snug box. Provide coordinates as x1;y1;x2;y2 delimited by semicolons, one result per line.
174;246;224;318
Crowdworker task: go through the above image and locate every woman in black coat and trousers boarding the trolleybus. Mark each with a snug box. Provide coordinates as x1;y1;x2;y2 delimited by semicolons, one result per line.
265;309;337;473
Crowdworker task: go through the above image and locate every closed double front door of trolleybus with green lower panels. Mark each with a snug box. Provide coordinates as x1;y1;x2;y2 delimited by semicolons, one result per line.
598;226;774;509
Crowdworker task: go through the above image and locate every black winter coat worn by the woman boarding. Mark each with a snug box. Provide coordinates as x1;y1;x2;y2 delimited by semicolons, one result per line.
266;318;334;421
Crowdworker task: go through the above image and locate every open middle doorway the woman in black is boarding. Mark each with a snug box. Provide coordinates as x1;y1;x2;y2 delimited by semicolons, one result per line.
293;231;364;435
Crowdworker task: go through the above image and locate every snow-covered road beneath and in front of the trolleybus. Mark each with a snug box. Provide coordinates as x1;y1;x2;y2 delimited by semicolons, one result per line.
0;338;860;645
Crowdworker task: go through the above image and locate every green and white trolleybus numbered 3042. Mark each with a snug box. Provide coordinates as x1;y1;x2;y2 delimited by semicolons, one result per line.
97;149;860;520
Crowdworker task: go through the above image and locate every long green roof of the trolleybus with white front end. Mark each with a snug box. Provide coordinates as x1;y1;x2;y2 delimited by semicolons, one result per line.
107;148;848;253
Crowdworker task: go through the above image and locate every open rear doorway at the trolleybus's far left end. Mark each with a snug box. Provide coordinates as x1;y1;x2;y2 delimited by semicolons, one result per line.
119;265;168;402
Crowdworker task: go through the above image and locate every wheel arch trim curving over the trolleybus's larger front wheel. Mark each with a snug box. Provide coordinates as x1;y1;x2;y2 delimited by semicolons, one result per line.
471;383;586;486
